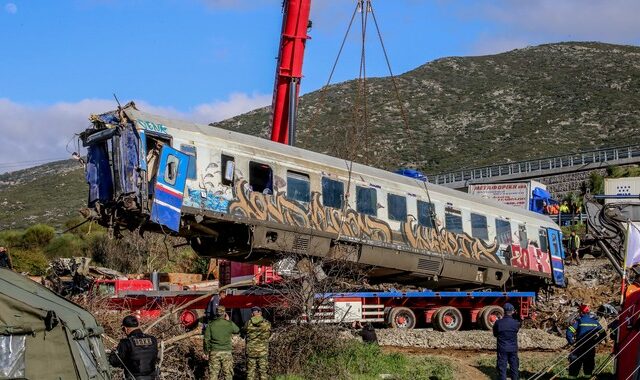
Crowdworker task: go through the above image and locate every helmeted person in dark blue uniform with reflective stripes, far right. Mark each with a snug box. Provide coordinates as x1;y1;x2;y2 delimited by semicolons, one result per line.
567;304;605;376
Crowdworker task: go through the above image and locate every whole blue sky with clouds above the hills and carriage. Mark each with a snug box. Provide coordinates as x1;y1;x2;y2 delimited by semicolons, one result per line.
0;0;640;173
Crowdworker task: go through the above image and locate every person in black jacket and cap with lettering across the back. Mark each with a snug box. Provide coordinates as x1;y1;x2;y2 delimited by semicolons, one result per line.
109;315;158;380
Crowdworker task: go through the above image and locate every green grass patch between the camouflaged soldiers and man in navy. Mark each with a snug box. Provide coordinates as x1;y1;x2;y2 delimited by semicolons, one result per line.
277;342;454;380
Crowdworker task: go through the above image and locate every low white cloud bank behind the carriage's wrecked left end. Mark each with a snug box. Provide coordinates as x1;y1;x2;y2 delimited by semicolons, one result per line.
0;93;271;173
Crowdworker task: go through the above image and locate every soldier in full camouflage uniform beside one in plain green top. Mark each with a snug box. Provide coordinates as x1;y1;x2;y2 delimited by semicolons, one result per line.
244;306;271;380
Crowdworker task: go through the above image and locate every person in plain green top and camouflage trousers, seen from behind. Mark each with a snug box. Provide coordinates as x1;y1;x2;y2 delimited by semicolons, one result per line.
204;306;240;380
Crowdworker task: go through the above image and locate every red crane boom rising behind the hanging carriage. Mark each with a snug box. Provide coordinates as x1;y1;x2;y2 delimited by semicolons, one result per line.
271;0;311;145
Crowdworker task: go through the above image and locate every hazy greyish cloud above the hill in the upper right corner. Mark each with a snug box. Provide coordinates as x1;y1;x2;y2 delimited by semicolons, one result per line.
459;0;640;54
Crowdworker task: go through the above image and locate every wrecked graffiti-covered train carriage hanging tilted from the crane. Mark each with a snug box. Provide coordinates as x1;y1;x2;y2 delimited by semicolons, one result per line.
81;103;565;290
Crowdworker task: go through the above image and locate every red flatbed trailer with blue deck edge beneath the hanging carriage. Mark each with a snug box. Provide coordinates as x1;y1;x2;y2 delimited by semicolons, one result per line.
222;290;536;331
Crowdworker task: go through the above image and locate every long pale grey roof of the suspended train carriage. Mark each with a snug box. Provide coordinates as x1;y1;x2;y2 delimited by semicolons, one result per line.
124;105;553;224
